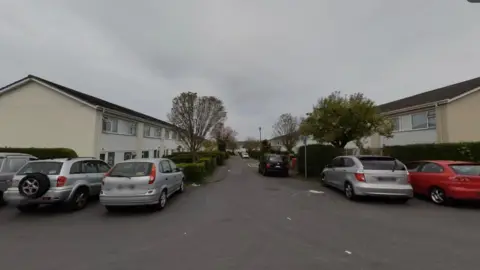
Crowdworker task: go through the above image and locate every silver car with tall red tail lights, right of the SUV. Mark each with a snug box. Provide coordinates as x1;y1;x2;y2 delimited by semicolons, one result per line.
100;158;185;211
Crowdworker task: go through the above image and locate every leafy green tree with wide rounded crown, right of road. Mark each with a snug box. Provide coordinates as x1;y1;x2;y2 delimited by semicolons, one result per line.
300;92;393;148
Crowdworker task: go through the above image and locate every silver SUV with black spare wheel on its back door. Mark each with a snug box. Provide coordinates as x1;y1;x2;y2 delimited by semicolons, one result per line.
3;157;110;212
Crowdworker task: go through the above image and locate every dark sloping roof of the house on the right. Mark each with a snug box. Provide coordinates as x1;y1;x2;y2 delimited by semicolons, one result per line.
378;77;480;112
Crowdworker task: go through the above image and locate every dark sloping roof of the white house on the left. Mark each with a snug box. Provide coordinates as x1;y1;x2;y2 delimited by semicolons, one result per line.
0;75;174;127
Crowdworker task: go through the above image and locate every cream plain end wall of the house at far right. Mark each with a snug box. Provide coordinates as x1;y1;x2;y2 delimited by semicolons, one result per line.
444;91;480;142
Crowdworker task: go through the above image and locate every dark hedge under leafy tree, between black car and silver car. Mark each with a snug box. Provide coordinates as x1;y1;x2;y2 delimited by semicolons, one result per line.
297;144;343;177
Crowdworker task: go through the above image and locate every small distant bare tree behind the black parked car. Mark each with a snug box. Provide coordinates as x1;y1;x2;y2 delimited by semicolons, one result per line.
273;113;300;152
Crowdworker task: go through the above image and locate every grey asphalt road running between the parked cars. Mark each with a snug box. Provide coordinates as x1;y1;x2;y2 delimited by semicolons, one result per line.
0;157;480;270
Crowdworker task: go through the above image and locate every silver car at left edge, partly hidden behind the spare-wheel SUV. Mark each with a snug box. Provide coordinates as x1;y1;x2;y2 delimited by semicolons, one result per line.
0;153;37;205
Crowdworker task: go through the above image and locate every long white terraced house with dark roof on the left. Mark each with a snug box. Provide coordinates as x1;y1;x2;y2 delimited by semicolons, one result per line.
0;75;181;164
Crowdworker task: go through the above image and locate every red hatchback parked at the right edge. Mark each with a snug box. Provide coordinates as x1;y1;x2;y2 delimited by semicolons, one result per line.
406;160;480;204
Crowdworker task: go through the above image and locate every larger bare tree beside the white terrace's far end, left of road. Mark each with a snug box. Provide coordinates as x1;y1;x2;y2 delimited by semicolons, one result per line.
168;92;227;161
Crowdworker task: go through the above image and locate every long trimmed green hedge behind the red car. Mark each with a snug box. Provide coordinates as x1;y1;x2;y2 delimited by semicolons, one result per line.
383;142;480;162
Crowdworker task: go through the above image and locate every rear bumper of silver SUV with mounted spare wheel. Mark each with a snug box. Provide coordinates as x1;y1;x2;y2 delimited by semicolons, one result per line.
3;188;72;205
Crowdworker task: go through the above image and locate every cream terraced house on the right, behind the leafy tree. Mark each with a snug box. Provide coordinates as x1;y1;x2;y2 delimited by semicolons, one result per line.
367;77;480;148
